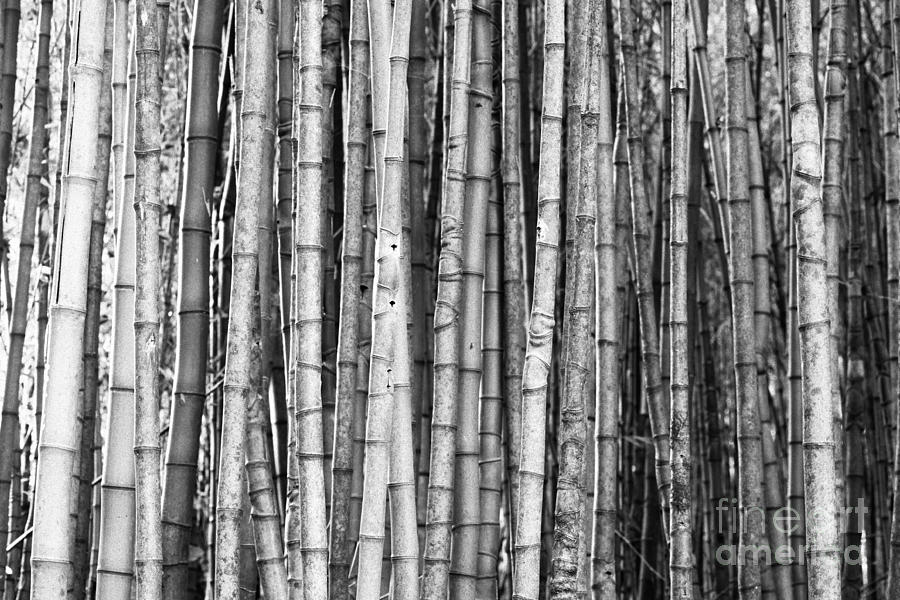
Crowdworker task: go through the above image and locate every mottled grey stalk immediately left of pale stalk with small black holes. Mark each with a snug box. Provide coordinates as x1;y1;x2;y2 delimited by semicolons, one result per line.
328;0;369;600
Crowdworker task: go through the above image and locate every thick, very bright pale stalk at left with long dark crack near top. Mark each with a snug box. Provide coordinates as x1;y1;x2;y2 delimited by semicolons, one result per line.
31;0;106;600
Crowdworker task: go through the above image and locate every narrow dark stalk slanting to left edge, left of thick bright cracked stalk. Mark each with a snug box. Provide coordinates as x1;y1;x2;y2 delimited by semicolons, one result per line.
0;0;53;582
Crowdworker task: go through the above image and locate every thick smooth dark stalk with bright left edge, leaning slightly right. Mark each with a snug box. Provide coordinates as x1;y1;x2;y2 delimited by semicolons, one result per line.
162;0;223;600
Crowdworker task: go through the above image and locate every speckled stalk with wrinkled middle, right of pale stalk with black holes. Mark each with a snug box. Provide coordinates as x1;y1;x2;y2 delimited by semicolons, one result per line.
420;0;472;600
